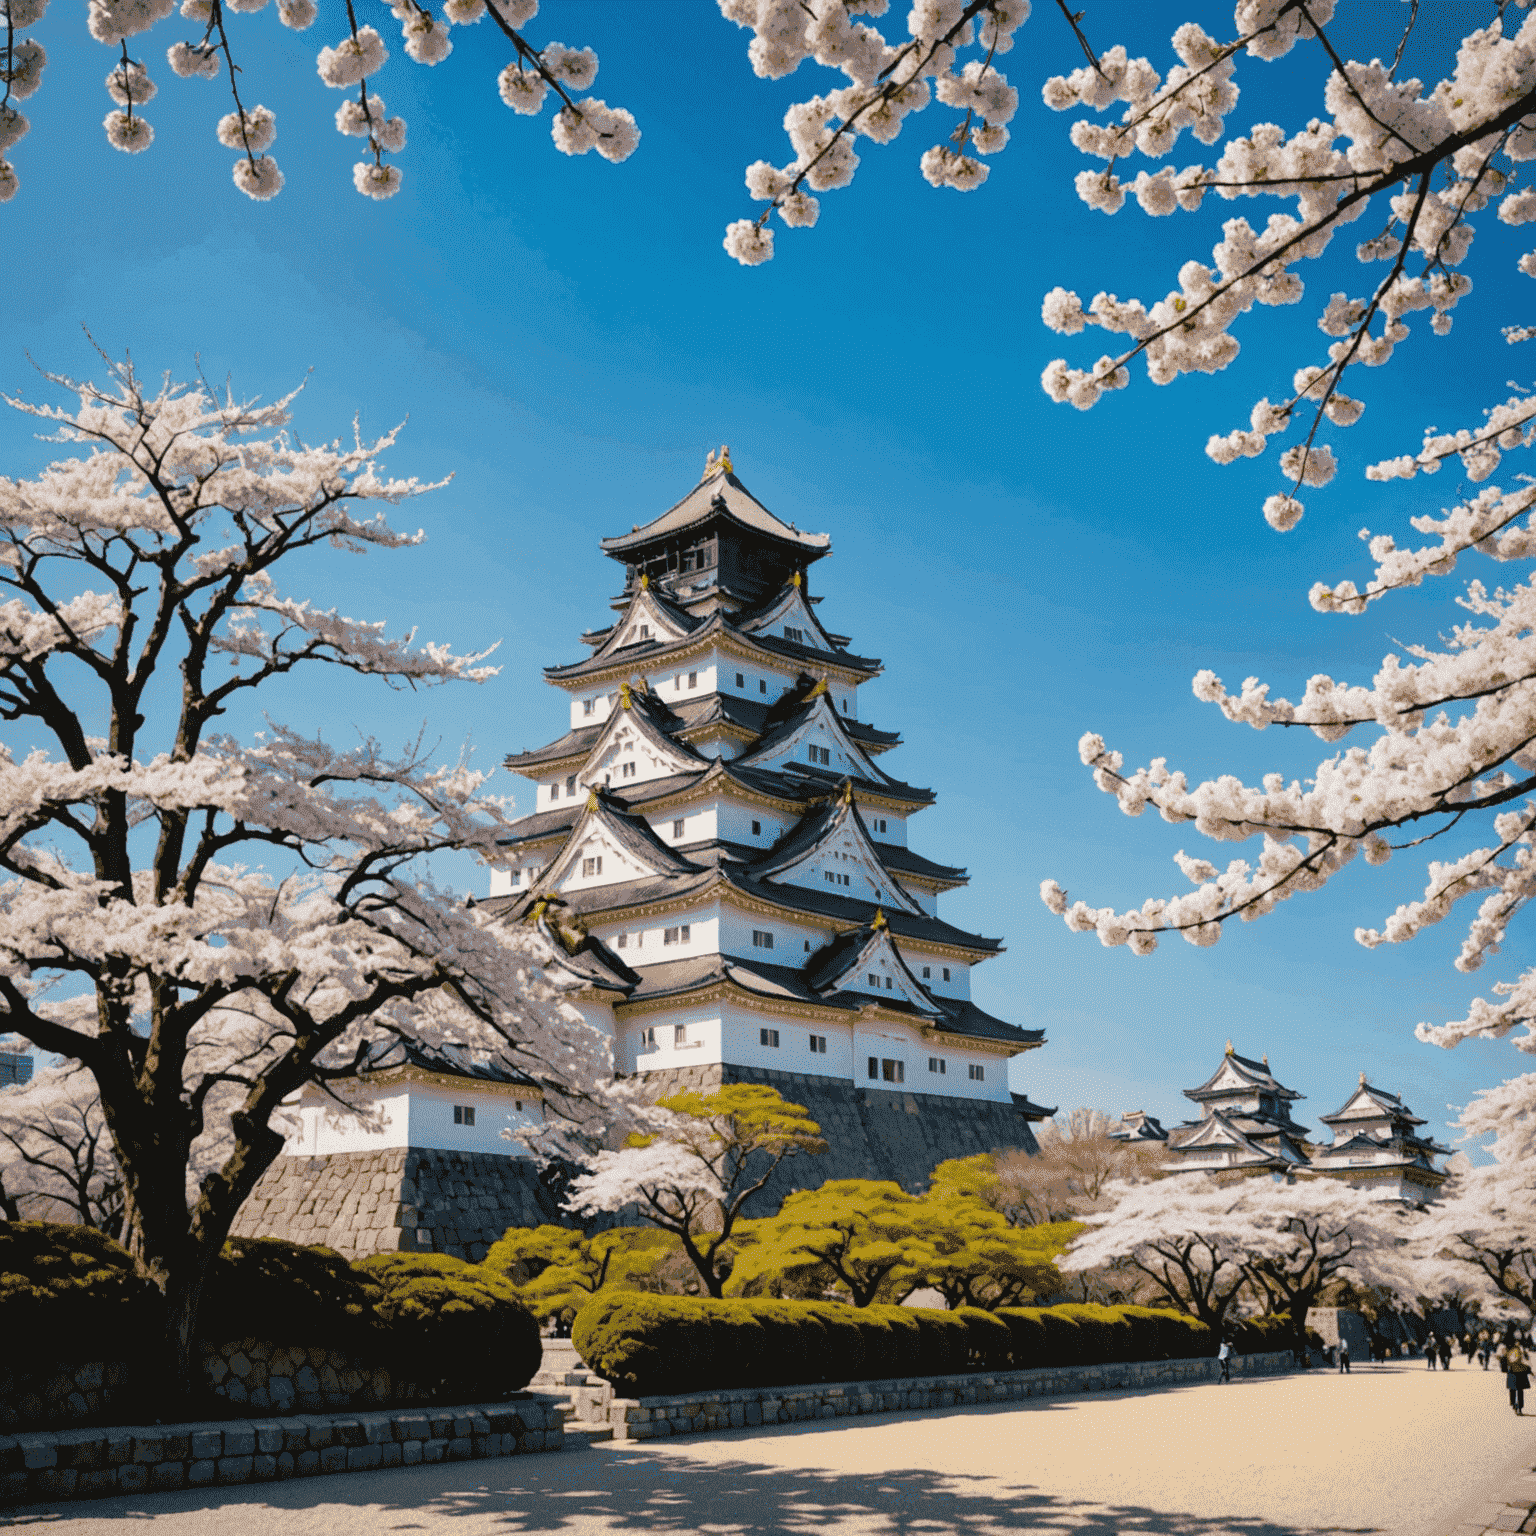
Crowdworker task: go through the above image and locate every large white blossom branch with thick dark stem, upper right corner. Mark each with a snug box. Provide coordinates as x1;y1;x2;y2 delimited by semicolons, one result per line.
1041;0;1536;531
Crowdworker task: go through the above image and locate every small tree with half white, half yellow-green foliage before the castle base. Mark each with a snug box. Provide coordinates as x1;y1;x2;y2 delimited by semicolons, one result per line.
567;1083;826;1296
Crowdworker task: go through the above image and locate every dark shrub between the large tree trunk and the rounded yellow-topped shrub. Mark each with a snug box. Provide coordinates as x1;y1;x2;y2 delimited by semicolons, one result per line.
198;1238;389;1362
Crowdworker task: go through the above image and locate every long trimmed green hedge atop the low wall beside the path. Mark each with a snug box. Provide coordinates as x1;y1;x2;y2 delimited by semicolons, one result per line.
571;1292;1217;1396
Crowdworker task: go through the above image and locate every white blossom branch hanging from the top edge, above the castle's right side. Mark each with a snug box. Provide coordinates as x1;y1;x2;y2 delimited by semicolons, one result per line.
719;0;1031;266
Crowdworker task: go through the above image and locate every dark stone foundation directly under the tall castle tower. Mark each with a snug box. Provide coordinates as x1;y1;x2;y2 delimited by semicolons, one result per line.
626;1063;1038;1217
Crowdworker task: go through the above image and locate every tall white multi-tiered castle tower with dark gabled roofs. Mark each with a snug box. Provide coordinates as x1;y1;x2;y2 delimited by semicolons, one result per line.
487;449;1052;1136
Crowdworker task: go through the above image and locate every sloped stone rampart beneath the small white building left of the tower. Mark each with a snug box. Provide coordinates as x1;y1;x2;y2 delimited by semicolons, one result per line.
224;1147;571;1261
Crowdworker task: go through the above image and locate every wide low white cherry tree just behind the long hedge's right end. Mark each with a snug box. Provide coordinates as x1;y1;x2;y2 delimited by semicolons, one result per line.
1057;1174;1407;1338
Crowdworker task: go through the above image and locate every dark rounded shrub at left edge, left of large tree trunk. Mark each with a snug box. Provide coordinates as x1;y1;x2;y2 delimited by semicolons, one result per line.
0;1221;166;1372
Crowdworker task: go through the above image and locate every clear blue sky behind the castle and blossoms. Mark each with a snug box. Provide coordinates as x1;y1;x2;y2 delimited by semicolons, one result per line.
0;0;1531;1138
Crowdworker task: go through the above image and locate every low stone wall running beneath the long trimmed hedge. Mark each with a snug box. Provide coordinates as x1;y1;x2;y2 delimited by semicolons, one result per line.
592;1350;1295;1439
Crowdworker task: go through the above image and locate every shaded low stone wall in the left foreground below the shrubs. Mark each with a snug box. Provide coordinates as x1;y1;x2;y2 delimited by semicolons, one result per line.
0;1392;565;1504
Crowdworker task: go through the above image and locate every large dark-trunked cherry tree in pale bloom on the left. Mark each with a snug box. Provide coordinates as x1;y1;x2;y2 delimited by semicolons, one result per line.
0;351;599;1390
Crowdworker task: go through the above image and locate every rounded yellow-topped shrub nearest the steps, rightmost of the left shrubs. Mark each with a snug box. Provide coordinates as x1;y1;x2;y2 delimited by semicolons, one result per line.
353;1253;544;1401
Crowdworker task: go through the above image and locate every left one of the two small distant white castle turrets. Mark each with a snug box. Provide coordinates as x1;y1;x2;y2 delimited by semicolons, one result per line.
1167;1040;1307;1174
